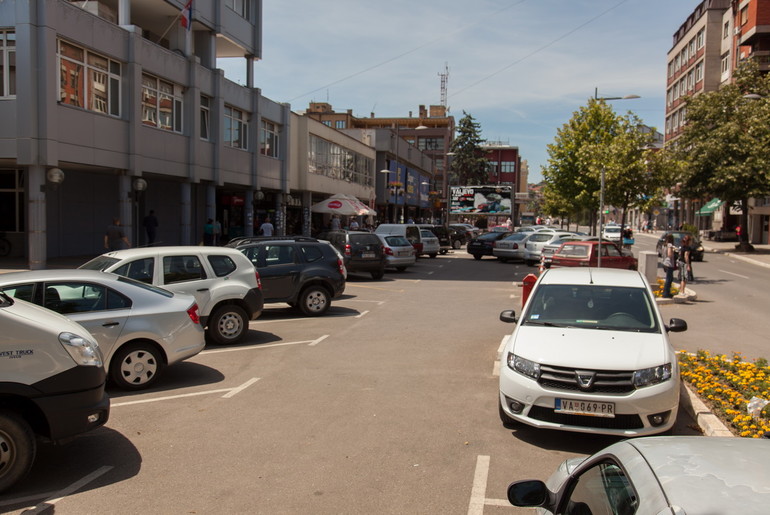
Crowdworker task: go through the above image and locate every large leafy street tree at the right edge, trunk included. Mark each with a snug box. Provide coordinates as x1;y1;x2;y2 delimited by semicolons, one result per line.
667;60;770;251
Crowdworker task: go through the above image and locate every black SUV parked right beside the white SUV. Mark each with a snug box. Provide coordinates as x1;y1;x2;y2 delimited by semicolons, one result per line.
228;236;346;316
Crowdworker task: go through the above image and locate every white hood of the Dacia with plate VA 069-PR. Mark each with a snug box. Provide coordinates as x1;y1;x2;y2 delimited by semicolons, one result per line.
510;325;673;370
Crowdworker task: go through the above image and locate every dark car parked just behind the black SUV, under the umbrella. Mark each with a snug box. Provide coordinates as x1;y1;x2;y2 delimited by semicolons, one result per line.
318;231;385;279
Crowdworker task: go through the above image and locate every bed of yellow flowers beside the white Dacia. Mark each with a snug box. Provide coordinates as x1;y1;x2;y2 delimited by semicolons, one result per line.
679;350;770;438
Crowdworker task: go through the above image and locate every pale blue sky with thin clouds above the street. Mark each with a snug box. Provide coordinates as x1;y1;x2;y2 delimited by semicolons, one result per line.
218;0;700;183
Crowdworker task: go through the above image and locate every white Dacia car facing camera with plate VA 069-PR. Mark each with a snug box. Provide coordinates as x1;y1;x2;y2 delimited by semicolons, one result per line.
499;268;687;436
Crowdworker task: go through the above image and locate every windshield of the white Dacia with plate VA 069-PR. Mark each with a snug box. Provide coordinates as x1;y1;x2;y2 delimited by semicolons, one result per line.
522;284;659;333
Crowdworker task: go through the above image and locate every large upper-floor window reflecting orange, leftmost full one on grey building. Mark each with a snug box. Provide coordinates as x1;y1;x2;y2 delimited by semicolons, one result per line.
58;40;121;116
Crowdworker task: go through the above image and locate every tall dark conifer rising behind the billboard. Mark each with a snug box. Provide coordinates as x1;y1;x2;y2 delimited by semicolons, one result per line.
449;111;489;186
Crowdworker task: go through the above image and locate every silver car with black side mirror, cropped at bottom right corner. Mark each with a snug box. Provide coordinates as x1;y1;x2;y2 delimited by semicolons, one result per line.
508;436;770;515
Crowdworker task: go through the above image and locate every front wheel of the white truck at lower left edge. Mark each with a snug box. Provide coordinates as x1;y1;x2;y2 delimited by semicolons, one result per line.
0;411;37;492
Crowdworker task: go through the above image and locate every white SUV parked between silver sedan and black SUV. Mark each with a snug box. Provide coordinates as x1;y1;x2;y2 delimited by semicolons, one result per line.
80;246;264;344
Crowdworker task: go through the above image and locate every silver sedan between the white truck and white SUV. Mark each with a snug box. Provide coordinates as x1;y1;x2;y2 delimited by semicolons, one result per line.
0;270;206;390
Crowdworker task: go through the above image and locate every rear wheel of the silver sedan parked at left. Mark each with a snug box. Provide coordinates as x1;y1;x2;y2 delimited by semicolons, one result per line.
110;343;163;390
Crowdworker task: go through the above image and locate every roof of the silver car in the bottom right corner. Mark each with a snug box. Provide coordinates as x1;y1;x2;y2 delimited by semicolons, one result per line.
621;436;770;513
